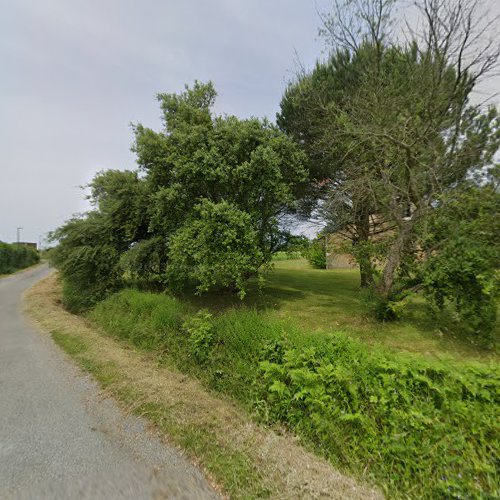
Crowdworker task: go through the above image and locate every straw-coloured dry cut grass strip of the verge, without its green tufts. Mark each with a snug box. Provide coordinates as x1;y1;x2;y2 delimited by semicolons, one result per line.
25;274;383;499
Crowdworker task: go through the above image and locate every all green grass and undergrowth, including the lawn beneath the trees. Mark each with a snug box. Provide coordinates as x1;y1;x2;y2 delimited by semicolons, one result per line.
66;260;500;498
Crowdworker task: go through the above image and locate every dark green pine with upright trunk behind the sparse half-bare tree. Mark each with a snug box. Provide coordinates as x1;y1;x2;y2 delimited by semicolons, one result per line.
278;45;396;288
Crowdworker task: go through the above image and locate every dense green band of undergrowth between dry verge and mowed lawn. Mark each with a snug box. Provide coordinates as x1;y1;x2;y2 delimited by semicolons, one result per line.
89;290;500;498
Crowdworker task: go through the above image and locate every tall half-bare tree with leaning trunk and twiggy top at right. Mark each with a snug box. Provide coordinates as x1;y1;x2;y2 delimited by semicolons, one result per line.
282;0;500;300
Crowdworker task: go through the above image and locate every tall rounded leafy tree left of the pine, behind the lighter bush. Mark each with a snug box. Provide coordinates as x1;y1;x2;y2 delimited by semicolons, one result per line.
134;83;306;291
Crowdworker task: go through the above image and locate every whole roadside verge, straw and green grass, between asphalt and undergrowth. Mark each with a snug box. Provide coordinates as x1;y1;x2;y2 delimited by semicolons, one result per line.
26;276;380;499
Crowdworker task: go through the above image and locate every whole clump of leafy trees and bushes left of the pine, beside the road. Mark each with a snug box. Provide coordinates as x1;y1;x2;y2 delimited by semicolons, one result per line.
52;82;306;308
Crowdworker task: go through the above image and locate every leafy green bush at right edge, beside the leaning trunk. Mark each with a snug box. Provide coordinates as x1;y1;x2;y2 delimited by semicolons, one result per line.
421;182;500;347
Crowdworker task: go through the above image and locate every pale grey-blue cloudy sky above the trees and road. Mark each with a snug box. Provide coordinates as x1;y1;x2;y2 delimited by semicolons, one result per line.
0;0;500;246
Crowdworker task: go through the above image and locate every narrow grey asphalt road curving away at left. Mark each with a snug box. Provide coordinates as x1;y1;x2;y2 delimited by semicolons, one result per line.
0;266;217;500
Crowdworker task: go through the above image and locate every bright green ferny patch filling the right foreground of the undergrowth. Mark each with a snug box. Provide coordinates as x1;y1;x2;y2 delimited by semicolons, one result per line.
257;335;500;498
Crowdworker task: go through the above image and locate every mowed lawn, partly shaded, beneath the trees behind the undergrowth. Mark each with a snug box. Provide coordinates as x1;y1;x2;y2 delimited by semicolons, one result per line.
187;259;498;361
